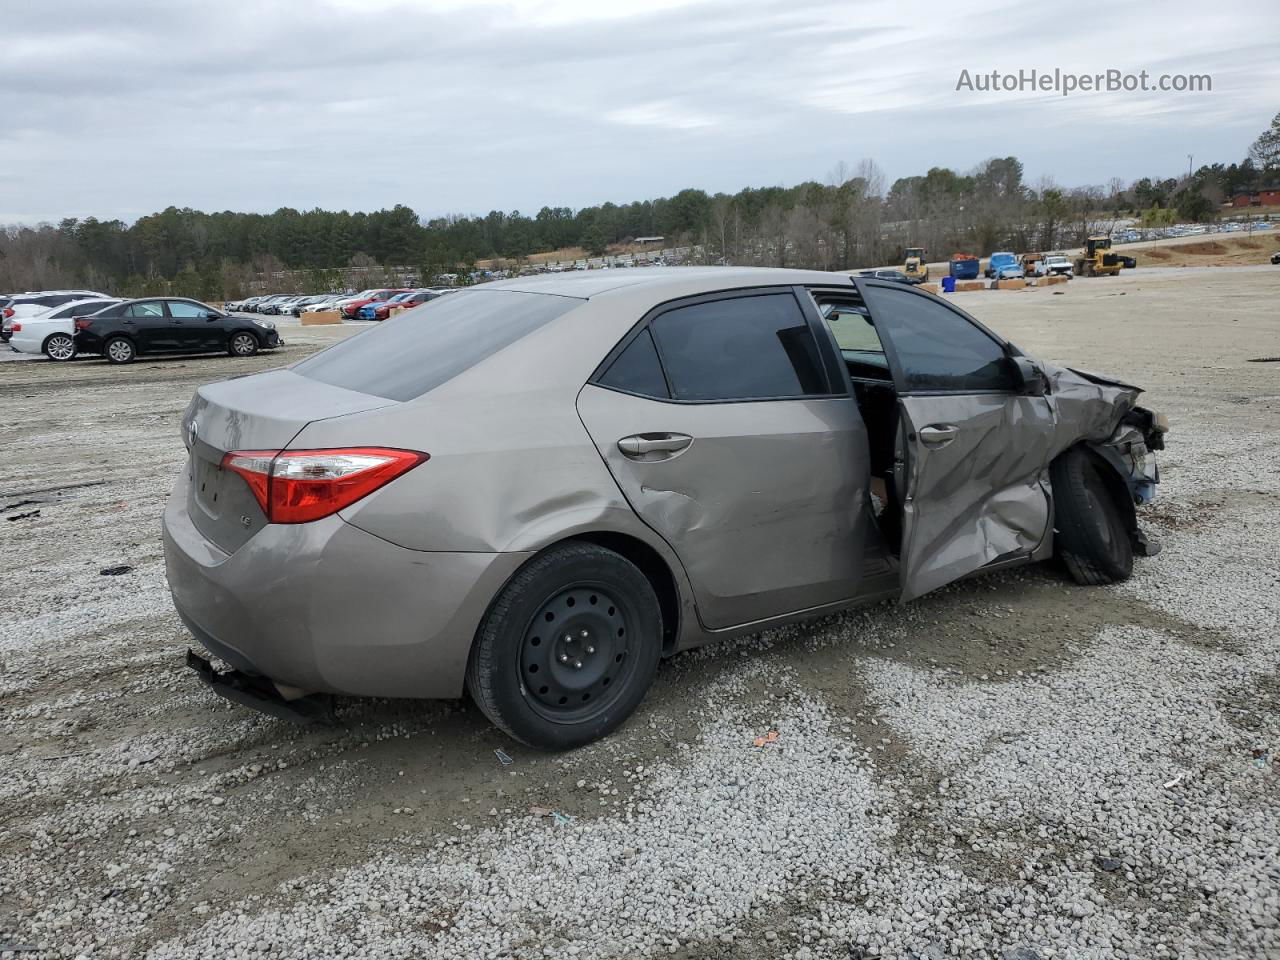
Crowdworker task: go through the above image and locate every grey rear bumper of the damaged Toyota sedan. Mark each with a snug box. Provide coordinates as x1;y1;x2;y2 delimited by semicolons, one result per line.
164;474;530;698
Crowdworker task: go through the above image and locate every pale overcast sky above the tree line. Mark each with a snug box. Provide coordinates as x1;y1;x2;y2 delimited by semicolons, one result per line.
0;0;1280;223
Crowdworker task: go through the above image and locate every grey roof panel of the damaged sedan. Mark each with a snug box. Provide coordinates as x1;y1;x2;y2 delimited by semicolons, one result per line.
471;266;852;300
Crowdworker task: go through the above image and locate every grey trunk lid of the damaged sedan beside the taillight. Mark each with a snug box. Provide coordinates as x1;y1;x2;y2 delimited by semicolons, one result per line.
182;370;394;553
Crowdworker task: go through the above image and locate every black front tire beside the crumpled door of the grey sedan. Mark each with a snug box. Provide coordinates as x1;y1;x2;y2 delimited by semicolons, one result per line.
1050;447;1133;585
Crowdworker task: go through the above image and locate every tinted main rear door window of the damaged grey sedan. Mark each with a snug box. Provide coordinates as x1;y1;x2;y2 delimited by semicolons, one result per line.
650;291;829;401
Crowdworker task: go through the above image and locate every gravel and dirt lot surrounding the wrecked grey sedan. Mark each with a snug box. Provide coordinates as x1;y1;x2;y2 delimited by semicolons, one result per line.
0;268;1280;960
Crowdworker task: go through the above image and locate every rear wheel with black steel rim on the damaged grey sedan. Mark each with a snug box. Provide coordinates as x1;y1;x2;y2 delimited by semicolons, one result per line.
467;543;662;750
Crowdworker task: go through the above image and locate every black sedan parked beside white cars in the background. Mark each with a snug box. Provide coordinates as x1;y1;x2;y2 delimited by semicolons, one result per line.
76;297;284;364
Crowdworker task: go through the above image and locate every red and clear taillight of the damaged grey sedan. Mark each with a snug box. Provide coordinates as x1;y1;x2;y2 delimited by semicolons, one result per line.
223;447;429;524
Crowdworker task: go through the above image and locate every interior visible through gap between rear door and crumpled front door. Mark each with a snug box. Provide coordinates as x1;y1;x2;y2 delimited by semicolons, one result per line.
815;293;902;554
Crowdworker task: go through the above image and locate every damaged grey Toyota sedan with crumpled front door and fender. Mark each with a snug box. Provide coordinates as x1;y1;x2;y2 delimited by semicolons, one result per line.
164;268;1166;749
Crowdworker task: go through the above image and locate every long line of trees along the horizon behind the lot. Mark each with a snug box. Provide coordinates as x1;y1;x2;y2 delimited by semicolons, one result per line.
0;108;1280;300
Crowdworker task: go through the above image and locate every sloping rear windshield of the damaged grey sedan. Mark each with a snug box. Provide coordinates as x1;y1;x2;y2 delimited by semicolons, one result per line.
293;291;582;401
